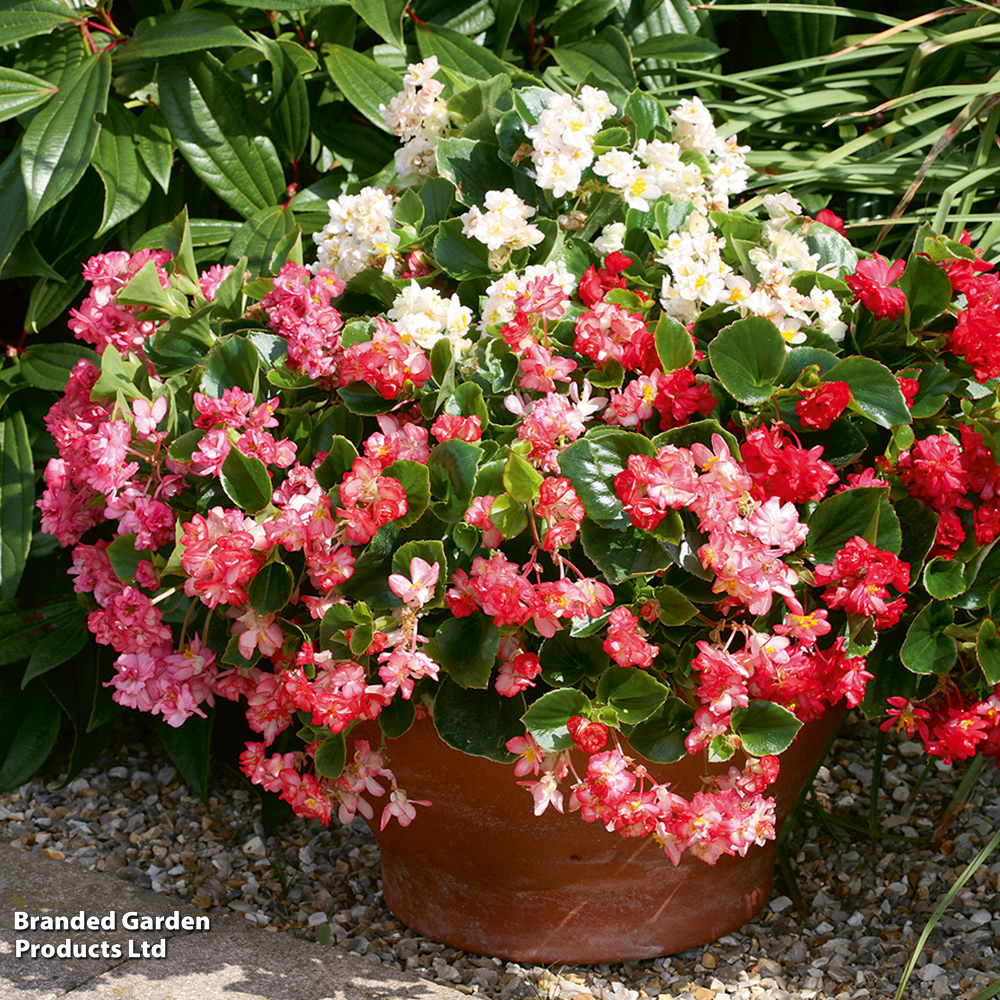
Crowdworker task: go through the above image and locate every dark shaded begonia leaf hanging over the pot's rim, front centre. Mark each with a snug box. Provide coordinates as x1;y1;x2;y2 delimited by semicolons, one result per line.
432;677;524;763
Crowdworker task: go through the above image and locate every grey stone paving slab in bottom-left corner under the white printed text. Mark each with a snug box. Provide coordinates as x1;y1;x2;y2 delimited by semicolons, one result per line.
0;844;463;1000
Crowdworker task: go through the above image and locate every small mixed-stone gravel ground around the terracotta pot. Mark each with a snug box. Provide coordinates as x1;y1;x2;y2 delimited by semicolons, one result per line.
0;724;1000;1000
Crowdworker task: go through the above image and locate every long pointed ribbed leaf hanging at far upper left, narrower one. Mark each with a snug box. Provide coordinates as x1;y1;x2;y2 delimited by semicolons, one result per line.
21;52;111;226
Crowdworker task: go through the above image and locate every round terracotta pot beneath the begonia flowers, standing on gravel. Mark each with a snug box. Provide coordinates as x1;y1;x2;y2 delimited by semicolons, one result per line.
355;710;844;964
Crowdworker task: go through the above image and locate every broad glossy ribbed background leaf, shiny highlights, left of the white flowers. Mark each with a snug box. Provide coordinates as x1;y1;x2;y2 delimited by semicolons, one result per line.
158;52;285;219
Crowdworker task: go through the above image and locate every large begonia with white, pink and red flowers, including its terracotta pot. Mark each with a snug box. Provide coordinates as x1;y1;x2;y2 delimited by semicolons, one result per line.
39;58;1000;961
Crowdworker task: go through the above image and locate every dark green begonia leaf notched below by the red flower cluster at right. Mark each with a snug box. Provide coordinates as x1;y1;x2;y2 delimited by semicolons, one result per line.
806;486;902;563
